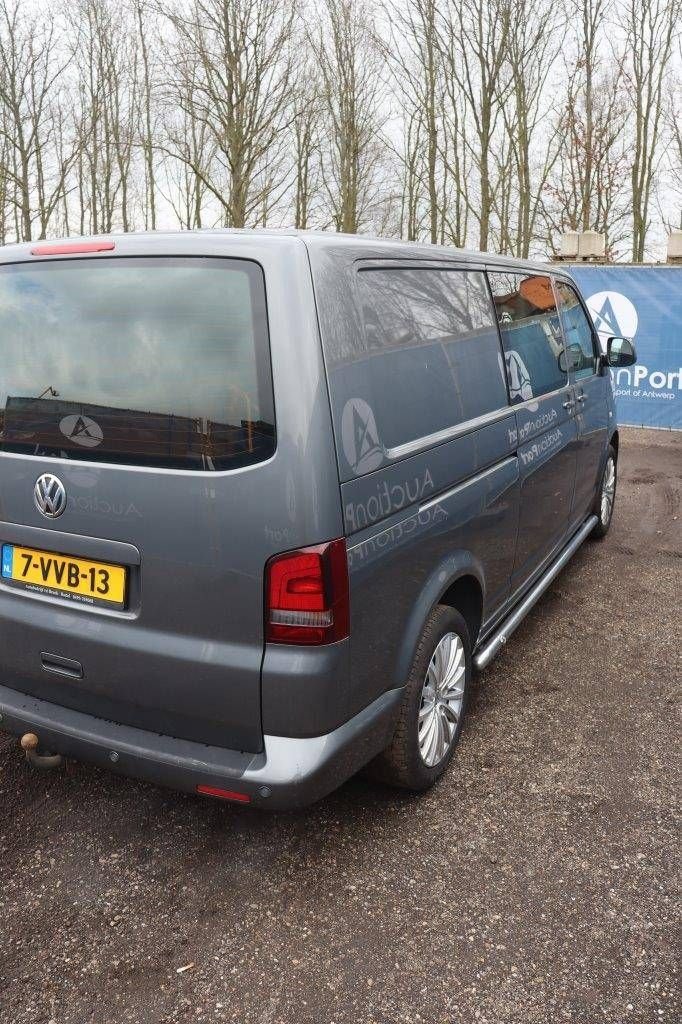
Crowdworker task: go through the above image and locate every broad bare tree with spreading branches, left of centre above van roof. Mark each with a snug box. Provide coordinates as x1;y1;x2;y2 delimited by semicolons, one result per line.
168;0;296;227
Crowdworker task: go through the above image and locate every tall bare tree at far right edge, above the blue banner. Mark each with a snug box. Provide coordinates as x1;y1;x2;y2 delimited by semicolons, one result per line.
624;0;682;262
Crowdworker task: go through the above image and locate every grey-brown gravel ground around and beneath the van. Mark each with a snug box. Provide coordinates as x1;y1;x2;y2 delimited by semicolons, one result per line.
0;431;682;1024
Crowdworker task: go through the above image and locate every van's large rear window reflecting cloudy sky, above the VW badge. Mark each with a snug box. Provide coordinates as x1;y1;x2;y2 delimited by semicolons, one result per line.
0;258;274;470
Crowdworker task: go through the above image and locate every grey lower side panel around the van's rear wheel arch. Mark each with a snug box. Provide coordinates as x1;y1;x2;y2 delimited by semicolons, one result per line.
348;452;519;708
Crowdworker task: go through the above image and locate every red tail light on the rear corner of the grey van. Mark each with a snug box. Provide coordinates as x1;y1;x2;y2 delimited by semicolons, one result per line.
265;540;349;644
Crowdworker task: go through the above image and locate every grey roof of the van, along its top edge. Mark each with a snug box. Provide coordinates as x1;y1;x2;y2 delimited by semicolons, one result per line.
0;227;569;275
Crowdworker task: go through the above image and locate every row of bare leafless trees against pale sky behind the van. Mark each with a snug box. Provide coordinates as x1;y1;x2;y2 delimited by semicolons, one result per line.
0;0;682;259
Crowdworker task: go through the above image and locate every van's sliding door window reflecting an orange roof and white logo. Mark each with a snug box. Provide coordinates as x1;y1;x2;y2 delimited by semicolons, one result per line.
488;271;568;402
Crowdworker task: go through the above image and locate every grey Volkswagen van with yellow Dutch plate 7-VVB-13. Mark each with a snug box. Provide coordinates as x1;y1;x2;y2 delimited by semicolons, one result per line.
0;231;635;808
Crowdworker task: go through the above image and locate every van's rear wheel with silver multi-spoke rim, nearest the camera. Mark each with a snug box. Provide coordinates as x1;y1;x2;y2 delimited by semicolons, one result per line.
369;604;472;793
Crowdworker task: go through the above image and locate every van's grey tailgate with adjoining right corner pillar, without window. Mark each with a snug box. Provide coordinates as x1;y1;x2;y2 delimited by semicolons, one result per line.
0;234;342;751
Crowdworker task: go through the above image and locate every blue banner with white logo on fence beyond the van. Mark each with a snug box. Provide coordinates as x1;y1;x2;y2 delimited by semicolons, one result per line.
567;263;682;430
